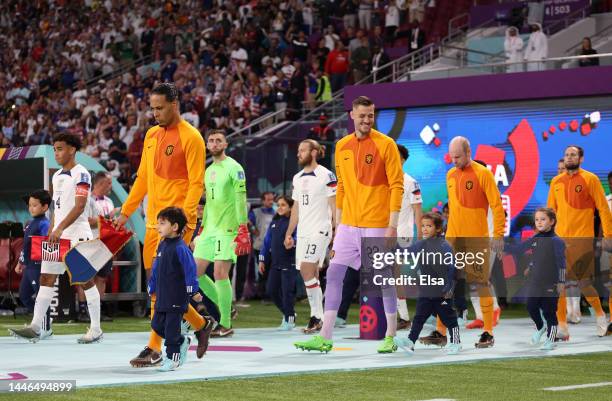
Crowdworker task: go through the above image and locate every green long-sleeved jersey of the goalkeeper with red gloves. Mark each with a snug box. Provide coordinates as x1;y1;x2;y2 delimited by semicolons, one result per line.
203;157;247;236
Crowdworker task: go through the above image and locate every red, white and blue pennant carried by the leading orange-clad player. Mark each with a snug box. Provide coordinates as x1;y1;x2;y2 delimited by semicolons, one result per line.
64;216;132;285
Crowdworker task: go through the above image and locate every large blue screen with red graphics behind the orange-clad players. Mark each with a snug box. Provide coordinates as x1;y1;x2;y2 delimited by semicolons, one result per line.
376;97;612;236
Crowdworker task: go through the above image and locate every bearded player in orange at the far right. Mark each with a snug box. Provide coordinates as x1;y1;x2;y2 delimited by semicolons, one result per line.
548;145;612;341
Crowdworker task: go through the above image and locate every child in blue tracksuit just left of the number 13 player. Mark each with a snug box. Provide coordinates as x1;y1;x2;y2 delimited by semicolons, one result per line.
259;196;297;331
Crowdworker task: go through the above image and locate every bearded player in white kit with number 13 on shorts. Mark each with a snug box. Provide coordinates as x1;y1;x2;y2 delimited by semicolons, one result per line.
285;139;337;333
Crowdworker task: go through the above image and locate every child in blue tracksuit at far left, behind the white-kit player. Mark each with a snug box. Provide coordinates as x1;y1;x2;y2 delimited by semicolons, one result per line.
15;189;51;332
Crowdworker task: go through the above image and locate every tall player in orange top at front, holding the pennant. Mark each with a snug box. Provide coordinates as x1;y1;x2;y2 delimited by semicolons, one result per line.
116;83;215;368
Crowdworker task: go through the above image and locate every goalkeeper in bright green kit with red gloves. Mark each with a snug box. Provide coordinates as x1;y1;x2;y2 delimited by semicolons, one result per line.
193;130;251;337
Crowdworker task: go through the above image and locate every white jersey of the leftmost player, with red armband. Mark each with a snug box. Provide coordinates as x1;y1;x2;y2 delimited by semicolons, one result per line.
53;164;93;241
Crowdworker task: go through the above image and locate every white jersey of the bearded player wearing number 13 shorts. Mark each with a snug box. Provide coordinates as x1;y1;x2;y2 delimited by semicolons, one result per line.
291;165;338;237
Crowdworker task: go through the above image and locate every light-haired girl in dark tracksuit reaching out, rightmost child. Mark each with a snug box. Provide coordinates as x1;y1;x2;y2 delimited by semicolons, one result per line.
506;207;565;351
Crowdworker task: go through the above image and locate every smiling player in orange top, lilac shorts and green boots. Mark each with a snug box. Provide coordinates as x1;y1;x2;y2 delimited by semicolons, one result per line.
294;96;404;353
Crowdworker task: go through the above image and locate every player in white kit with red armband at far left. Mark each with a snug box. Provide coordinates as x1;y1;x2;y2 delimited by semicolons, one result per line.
11;134;102;344
